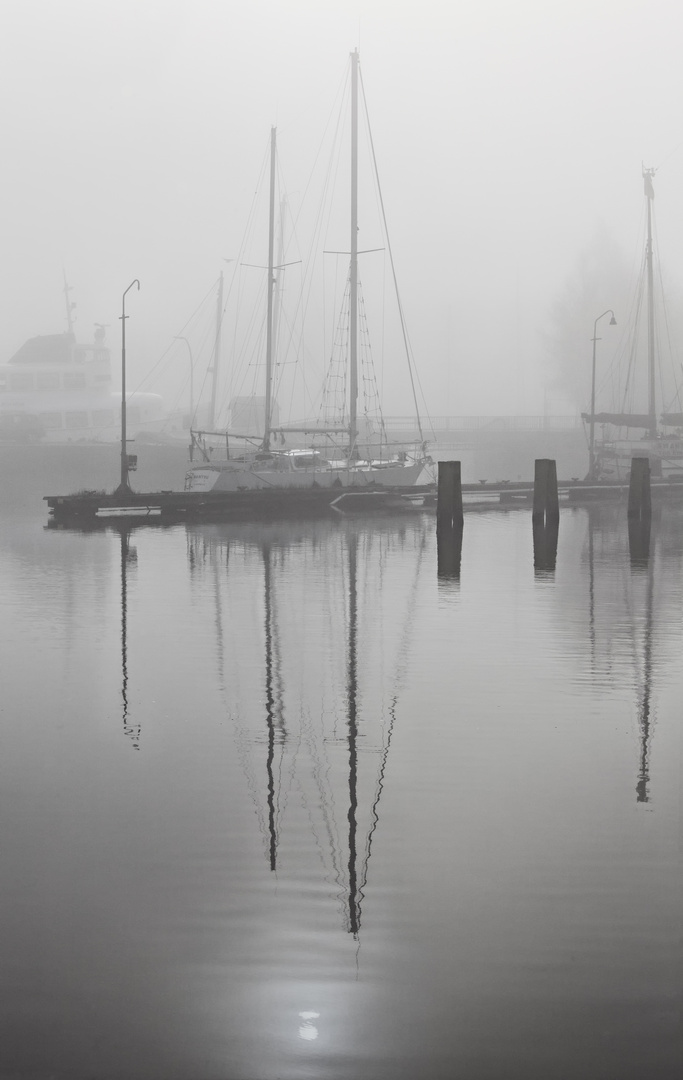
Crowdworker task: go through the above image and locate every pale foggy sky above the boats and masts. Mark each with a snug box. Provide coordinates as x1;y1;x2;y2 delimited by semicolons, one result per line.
0;0;683;414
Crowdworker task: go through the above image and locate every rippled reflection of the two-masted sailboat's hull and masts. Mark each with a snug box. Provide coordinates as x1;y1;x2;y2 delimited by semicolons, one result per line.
188;519;431;940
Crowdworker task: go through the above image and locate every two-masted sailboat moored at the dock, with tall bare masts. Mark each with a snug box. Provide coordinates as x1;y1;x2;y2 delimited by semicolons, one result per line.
185;50;430;492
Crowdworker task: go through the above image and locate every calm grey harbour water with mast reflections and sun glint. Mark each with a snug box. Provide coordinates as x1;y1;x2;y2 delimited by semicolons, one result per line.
0;509;683;1080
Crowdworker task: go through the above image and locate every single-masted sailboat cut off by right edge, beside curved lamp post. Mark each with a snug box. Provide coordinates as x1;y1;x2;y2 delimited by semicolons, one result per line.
581;166;683;481
